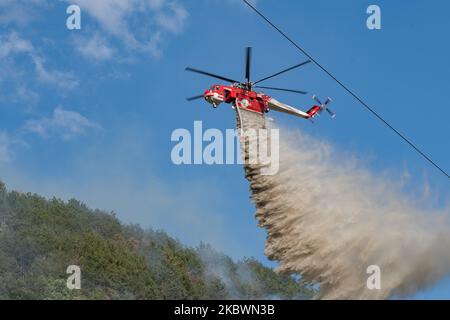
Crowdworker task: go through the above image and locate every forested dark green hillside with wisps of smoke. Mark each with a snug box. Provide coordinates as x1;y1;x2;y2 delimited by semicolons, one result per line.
0;182;314;299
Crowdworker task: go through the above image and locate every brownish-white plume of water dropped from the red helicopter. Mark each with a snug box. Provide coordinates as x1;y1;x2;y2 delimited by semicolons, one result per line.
238;111;450;299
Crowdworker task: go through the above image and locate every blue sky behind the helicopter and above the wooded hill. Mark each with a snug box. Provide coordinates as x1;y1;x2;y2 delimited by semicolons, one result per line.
0;0;450;298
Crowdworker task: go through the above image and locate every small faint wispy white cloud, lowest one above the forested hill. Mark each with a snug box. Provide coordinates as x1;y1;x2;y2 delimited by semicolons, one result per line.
23;107;101;140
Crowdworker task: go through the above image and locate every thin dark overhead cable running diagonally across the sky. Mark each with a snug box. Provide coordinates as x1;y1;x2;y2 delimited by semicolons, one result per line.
243;0;450;179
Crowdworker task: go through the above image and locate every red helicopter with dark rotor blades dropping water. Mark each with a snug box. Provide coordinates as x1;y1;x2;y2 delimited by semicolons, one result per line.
186;47;336;120
